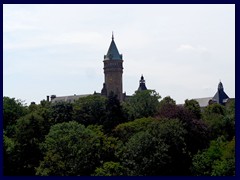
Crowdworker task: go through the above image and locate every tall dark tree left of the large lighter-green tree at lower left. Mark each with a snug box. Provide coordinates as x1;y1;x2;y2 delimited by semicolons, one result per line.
11;113;48;175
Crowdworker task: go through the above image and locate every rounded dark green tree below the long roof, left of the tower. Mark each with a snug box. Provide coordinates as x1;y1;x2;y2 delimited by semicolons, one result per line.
73;95;107;125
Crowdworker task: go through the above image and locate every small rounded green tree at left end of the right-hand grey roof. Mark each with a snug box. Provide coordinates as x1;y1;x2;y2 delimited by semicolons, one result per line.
184;99;201;119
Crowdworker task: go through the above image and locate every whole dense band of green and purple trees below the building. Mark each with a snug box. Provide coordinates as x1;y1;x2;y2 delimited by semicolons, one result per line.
3;95;235;176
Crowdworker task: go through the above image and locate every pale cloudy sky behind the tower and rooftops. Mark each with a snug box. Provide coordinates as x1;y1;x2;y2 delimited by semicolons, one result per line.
3;4;235;104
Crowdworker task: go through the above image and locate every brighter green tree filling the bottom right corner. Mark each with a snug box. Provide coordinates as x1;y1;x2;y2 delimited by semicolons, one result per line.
192;137;235;176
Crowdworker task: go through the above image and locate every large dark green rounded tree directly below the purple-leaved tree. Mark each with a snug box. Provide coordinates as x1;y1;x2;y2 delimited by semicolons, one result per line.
118;119;187;176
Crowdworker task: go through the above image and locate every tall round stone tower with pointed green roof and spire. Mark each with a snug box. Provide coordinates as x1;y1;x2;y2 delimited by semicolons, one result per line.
101;35;123;101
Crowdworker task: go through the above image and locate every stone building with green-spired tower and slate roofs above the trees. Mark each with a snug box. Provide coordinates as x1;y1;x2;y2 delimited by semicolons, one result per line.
47;35;231;107
